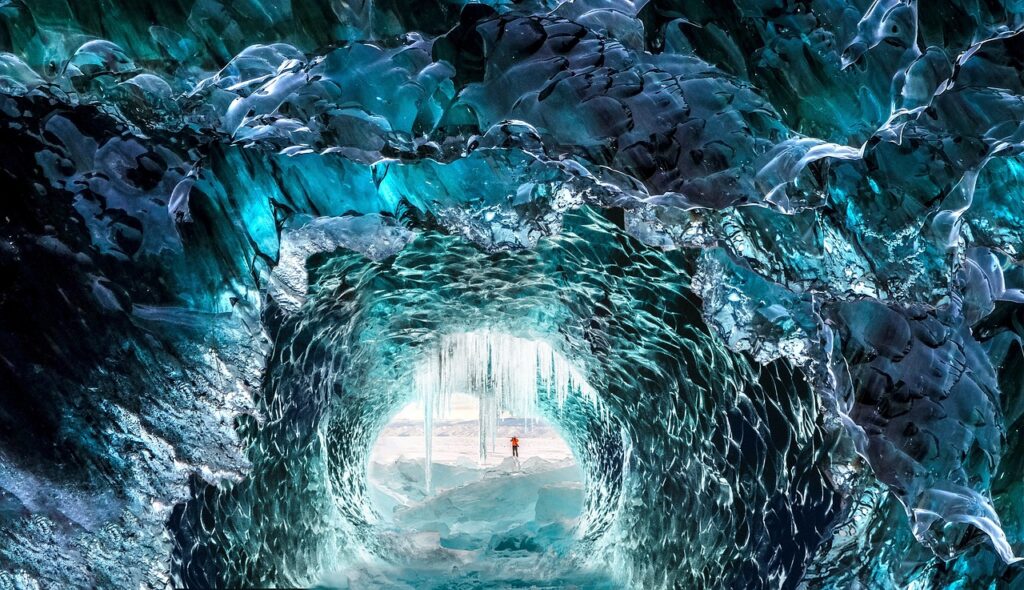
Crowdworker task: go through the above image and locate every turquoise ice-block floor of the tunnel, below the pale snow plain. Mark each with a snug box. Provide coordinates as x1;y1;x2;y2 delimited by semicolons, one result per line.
321;461;622;590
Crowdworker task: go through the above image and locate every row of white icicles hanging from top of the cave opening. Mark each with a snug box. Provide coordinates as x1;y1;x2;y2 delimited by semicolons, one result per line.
415;330;596;490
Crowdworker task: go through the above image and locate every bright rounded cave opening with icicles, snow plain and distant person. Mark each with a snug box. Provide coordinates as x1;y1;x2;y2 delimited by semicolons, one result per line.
368;331;590;552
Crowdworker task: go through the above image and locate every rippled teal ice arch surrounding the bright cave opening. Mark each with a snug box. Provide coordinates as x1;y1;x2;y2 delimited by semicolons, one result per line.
170;209;838;587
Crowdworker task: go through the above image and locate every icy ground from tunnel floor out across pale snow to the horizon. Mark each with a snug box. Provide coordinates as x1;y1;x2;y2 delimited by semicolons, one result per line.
323;421;618;590
